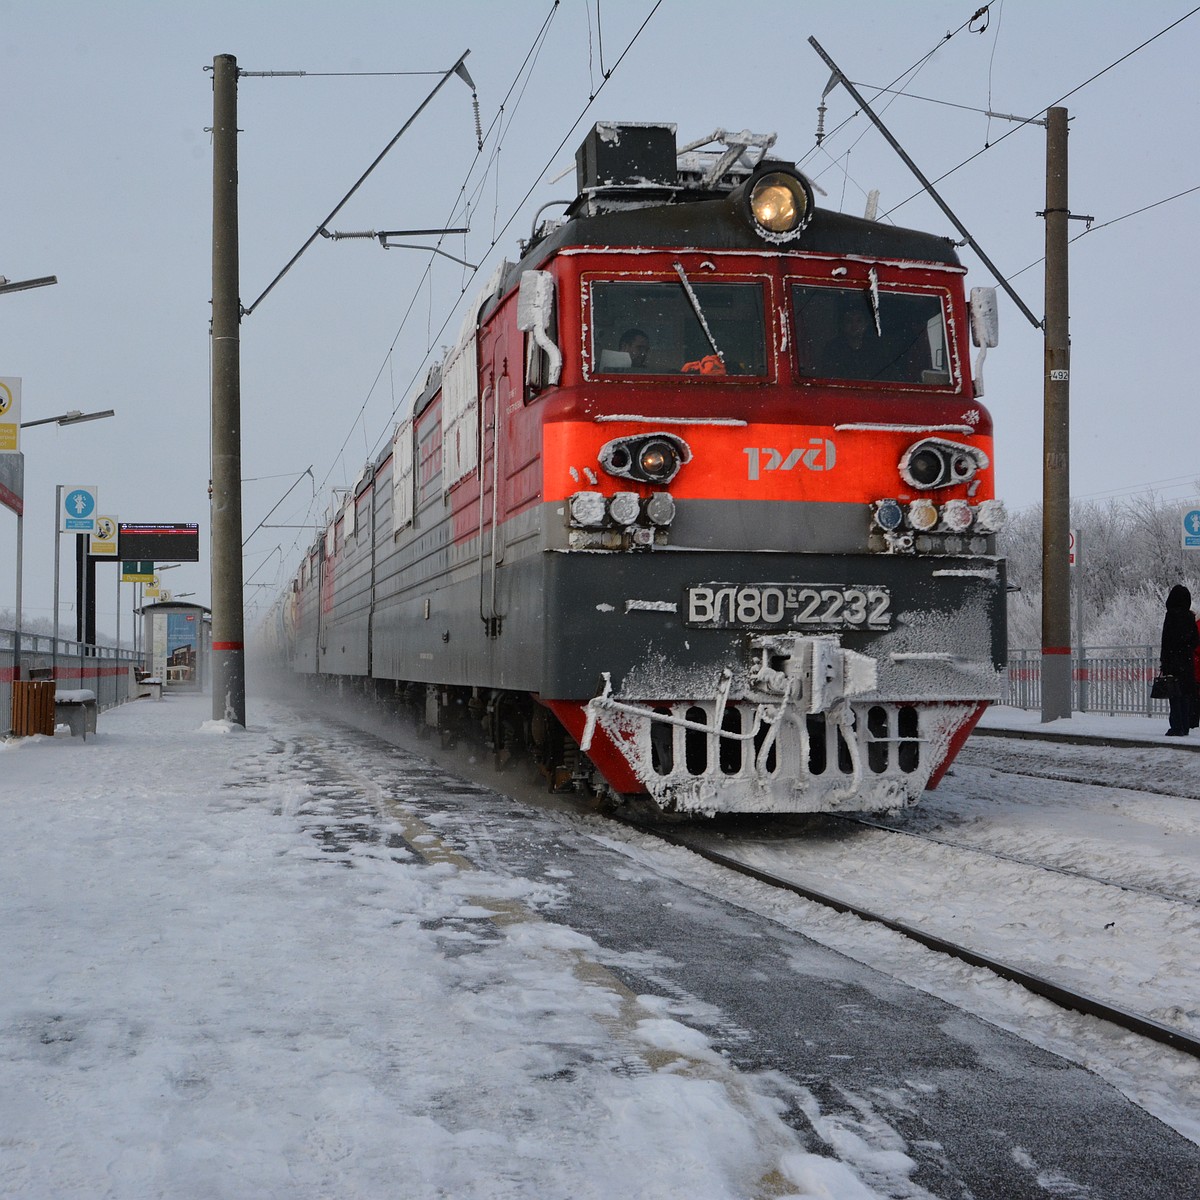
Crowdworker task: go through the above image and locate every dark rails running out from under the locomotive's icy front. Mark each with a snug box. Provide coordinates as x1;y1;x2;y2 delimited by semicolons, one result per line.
656;826;1200;1058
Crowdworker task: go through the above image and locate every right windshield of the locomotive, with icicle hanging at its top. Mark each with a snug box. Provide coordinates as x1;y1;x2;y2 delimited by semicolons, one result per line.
792;283;952;388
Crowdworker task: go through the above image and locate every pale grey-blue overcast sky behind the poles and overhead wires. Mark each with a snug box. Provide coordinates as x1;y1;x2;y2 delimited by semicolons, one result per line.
0;0;1200;631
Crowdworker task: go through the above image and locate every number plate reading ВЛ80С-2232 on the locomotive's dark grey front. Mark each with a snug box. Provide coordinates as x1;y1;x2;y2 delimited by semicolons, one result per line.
684;583;892;632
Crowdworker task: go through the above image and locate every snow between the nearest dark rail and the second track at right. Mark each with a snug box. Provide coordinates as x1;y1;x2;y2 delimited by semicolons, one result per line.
700;768;1200;1037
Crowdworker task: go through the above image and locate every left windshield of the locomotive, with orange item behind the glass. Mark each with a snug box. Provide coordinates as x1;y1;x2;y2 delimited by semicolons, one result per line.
592;276;767;376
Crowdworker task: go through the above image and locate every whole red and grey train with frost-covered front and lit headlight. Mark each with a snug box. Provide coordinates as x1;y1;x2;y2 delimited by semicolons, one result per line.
270;124;1006;815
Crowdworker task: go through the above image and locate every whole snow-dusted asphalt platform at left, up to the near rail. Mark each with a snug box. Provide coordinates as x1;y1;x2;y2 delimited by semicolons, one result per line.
0;696;1200;1200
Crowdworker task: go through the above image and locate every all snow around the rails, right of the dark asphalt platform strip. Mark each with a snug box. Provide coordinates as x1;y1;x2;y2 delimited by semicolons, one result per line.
607;708;1200;1144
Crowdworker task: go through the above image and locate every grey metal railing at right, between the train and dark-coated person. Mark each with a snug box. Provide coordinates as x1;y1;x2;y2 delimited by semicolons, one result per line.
1003;646;1168;716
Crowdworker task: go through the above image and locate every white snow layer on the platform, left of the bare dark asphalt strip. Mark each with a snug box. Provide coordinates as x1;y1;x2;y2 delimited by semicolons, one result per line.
0;697;902;1200
